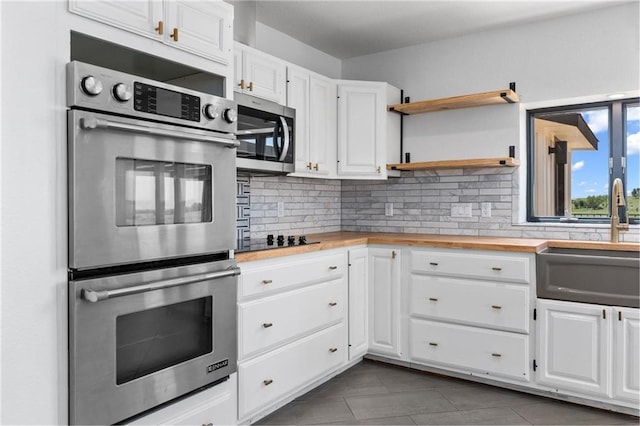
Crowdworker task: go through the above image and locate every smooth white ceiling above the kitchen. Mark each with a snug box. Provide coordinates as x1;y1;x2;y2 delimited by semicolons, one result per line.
256;0;638;59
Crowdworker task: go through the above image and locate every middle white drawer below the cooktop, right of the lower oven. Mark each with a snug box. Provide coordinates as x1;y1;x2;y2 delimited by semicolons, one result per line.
238;278;347;359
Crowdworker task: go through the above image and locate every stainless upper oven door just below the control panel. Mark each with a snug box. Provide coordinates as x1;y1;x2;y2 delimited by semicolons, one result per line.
68;110;237;269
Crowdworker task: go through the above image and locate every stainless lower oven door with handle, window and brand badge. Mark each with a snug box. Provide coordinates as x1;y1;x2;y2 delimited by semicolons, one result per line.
69;260;239;424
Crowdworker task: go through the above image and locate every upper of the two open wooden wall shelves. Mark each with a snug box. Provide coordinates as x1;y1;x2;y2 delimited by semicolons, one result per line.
388;89;520;115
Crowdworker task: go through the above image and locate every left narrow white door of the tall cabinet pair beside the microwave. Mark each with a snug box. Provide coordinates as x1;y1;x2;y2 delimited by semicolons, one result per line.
287;67;312;173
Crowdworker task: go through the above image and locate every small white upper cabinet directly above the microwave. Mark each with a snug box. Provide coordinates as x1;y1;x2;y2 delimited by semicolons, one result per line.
233;43;287;105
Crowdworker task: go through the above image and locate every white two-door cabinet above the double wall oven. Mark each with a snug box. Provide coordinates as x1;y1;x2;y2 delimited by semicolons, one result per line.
69;0;233;65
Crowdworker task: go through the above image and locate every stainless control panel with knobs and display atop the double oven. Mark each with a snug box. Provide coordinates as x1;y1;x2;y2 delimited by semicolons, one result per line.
67;61;237;134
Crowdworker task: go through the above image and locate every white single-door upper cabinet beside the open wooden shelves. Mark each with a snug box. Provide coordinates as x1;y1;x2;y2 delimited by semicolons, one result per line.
338;80;400;179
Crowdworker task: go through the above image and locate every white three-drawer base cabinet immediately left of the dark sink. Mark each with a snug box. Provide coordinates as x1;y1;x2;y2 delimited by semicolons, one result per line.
405;248;535;383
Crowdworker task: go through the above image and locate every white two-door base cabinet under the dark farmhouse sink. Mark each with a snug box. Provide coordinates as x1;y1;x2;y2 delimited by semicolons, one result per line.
536;299;640;408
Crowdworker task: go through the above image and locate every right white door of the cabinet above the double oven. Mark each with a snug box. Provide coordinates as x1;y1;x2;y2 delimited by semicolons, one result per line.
164;0;233;65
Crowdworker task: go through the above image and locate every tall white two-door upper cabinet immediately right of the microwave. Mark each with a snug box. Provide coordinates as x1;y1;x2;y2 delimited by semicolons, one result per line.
287;66;337;178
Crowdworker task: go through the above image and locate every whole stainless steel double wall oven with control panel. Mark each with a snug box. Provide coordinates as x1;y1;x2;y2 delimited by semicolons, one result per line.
67;62;239;424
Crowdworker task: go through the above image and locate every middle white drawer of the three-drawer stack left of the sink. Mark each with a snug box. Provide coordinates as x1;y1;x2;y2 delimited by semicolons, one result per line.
409;274;530;333
